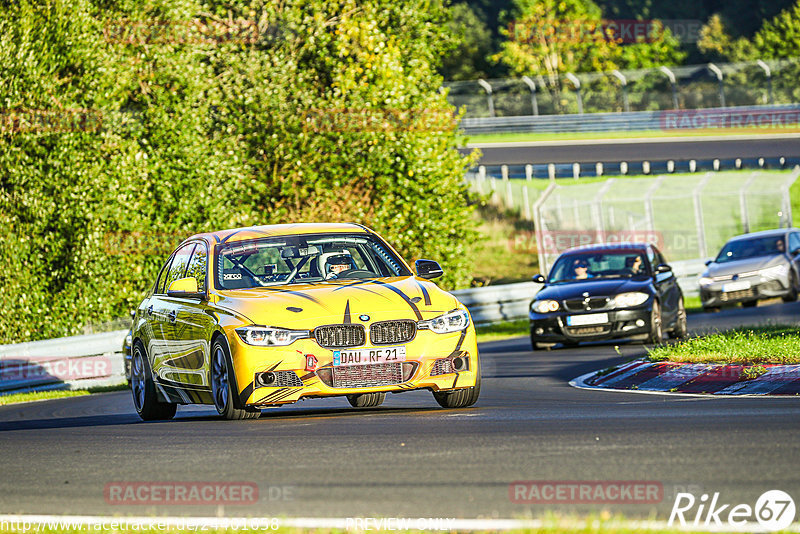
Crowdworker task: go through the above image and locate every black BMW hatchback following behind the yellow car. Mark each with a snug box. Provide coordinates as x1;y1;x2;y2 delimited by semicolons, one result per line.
529;243;686;350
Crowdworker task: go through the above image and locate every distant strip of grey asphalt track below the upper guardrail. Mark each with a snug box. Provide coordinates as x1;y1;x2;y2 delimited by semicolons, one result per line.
461;136;800;165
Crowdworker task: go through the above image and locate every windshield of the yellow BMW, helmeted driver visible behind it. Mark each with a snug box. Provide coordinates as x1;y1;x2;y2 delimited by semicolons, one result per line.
215;234;411;289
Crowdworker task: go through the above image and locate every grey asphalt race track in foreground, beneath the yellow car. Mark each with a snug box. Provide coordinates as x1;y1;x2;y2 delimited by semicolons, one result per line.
0;303;800;519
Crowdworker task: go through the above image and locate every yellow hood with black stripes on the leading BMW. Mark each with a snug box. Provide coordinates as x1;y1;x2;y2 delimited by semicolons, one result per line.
212;276;463;330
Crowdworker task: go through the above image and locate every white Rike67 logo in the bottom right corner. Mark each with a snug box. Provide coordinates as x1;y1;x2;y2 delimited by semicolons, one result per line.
668;490;796;532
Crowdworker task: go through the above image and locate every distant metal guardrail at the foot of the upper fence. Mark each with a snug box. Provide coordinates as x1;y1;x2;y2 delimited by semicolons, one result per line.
461;104;800;135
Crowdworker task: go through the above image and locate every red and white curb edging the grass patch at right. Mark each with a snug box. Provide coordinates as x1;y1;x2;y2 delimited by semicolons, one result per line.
569;360;800;397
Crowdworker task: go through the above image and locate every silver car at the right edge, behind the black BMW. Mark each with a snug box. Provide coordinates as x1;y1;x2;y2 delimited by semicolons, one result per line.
700;228;800;310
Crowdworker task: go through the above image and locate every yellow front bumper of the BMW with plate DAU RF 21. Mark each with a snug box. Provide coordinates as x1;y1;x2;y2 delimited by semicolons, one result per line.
228;325;480;406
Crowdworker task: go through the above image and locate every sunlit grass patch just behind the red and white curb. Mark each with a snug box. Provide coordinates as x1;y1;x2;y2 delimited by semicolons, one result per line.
648;324;800;364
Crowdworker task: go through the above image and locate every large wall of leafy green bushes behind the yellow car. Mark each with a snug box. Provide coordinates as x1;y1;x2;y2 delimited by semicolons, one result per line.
0;0;477;343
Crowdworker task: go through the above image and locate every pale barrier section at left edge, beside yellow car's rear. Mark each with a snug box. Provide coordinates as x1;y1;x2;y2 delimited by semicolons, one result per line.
0;330;128;391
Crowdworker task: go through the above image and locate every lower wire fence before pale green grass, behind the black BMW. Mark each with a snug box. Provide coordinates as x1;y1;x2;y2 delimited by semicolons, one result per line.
467;167;800;273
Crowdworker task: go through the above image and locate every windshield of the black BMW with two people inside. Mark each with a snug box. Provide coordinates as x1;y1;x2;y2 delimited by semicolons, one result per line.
547;250;649;284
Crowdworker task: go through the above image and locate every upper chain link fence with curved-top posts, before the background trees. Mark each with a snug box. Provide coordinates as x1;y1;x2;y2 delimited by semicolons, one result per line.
444;58;800;118
